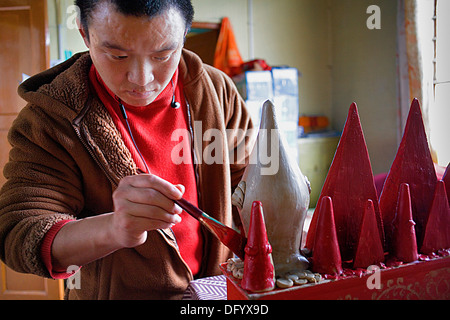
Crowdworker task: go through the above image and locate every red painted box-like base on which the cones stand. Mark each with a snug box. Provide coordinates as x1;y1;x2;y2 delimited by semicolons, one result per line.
221;256;450;300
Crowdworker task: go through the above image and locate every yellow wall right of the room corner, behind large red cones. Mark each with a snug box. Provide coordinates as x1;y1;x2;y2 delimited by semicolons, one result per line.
331;0;398;173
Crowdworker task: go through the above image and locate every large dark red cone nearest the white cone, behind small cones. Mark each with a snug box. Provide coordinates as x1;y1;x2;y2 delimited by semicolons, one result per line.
305;103;383;261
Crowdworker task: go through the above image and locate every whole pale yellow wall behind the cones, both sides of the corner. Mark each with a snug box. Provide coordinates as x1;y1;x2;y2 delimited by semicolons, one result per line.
193;0;398;173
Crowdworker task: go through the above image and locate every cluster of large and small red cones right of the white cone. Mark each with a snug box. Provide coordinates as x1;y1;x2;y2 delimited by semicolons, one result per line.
306;99;450;274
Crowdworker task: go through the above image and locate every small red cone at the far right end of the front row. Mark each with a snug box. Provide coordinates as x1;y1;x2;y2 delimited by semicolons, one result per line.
420;180;450;254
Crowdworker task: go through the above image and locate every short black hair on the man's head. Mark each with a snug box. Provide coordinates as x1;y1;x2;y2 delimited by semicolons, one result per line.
75;0;194;35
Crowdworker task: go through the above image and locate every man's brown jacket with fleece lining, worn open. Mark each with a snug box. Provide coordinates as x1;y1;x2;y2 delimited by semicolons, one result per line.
0;50;253;299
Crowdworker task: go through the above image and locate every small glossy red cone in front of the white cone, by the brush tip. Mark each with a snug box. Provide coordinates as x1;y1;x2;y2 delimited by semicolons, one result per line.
241;201;275;292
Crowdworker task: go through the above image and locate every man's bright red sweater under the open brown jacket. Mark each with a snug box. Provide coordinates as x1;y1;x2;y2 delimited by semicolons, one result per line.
41;65;203;278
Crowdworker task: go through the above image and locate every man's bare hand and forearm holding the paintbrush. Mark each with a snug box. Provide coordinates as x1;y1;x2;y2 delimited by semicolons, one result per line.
52;174;184;270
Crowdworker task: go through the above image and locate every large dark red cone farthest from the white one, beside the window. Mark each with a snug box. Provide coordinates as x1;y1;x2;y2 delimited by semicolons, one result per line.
380;99;437;251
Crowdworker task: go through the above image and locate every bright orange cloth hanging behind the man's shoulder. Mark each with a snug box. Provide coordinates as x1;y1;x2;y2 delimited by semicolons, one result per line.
213;17;243;77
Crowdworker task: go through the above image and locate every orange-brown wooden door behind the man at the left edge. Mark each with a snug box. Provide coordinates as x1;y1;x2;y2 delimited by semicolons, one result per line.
0;0;63;299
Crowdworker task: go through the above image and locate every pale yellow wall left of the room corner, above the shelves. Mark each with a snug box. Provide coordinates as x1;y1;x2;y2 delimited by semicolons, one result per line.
192;0;331;125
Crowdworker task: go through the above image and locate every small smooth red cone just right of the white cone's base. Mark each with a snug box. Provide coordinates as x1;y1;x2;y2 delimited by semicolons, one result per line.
312;197;342;275
